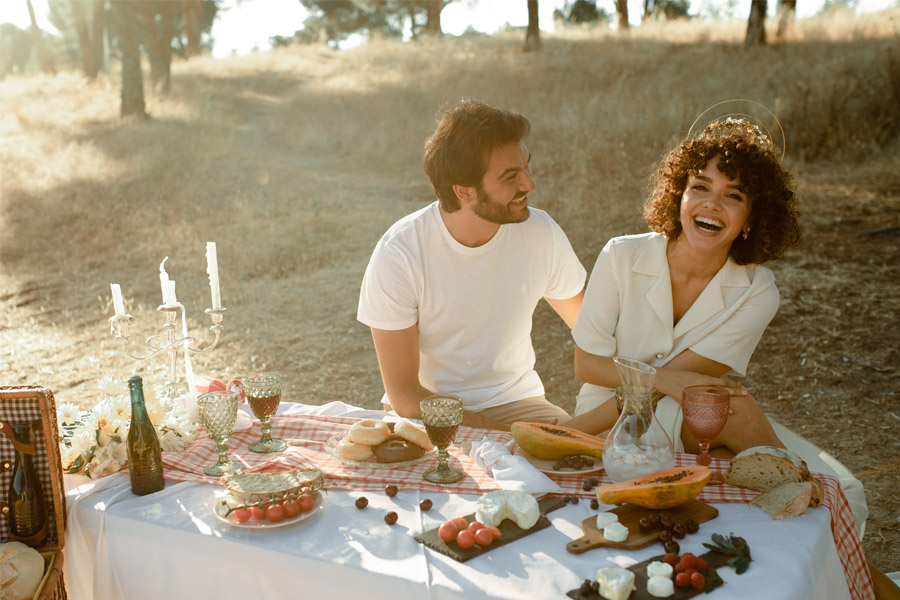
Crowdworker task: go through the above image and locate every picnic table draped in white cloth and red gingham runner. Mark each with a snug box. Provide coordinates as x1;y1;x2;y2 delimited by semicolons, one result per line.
64;402;874;600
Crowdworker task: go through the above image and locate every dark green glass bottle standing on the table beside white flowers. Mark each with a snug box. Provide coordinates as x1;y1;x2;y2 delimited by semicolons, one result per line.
127;375;166;496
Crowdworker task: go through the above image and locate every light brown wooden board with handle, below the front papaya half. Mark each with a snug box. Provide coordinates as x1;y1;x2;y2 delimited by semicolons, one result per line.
566;500;719;554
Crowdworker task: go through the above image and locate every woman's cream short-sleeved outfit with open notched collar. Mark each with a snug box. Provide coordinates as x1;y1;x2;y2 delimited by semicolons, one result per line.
572;233;779;446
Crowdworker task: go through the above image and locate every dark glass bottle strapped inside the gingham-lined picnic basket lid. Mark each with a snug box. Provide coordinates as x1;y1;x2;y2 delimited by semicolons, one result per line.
7;423;47;546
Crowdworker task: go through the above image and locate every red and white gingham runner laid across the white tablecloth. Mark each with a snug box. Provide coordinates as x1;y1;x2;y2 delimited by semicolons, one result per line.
163;415;875;600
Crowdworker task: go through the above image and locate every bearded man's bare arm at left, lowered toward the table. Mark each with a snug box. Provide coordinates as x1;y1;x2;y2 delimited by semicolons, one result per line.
372;325;509;431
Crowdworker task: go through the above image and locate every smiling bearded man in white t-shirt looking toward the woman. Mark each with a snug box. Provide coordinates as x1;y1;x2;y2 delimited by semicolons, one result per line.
357;100;586;429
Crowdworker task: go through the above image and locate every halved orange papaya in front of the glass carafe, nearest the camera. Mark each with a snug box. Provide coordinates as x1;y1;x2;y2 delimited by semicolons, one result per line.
594;465;712;508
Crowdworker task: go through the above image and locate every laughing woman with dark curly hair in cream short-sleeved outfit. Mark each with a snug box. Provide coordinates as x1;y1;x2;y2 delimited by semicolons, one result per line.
566;119;800;456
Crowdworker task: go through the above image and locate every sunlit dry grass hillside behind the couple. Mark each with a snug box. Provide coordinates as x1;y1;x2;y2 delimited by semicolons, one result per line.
0;11;900;571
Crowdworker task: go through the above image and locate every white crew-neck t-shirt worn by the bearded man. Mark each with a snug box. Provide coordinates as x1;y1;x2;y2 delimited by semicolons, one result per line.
357;202;586;410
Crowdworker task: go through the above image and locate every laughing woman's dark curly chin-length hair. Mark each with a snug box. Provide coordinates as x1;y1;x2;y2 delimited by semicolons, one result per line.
644;119;800;265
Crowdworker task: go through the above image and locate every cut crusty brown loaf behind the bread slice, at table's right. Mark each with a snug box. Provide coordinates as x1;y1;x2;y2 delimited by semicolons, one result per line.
725;446;825;506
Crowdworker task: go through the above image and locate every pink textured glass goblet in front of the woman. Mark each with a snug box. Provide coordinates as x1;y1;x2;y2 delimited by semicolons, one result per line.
681;385;731;485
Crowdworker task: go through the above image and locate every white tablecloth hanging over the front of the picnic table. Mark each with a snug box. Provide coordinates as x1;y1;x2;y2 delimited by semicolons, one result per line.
64;405;850;600
